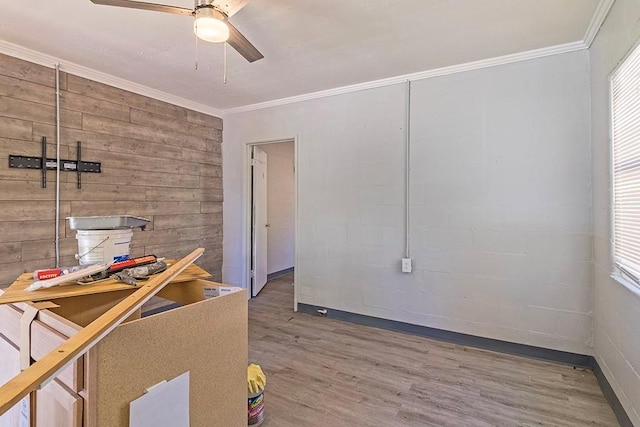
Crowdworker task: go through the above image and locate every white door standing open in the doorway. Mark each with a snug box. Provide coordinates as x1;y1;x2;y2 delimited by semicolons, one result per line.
251;146;269;297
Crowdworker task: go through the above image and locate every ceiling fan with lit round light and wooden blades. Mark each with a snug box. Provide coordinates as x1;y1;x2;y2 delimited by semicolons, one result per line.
91;0;264;62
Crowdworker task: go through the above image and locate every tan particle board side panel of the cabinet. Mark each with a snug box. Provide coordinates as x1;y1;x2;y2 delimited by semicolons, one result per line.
89;283;247;427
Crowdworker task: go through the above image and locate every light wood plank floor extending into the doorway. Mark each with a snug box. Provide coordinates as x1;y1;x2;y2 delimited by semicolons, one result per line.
249;275;618;427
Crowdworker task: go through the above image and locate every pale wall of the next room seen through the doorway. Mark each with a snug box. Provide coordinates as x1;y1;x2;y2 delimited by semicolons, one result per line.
260;141;296;274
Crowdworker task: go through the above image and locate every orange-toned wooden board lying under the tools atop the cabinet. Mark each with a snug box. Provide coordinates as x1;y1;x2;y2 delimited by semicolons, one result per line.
0;260;211;304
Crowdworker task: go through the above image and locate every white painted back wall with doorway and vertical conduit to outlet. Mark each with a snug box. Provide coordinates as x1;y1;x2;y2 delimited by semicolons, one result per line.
223;51;591;354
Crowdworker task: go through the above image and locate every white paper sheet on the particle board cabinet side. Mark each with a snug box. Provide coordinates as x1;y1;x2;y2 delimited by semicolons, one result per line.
129;371;189;427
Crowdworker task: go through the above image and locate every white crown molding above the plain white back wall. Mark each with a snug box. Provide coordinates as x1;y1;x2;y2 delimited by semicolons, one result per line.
223;40;588;116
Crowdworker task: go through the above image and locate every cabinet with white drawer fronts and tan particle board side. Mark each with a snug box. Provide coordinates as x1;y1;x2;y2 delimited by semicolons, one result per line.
0;280;248;427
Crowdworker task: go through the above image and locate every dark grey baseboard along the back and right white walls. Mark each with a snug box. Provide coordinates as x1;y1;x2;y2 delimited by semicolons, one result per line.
298;303;634;427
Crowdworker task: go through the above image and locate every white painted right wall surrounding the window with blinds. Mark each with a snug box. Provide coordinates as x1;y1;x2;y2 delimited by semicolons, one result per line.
590;0;640;426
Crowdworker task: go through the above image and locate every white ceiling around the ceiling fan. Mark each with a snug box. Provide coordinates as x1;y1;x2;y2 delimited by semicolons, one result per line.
0;0;611;110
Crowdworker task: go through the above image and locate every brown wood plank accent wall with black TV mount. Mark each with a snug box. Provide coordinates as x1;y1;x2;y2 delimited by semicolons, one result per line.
0;55;222;286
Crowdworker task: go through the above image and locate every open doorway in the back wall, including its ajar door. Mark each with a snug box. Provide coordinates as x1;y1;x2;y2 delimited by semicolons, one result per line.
247;139;297;307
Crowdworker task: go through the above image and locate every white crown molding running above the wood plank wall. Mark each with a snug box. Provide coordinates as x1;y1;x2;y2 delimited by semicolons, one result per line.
0;40;223;117
